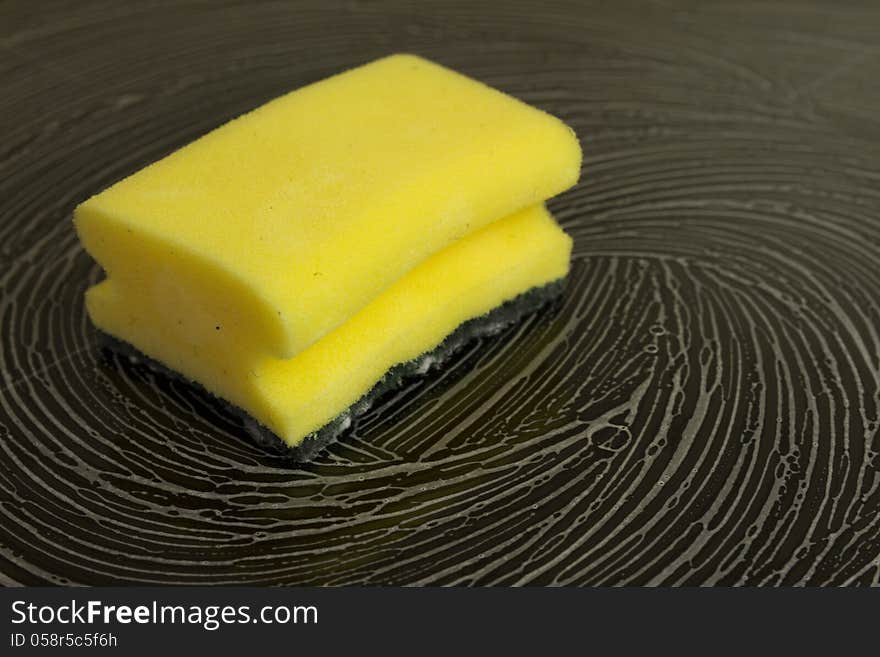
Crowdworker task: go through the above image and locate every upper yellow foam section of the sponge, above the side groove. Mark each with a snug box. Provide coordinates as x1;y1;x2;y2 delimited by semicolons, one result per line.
74;55;581;357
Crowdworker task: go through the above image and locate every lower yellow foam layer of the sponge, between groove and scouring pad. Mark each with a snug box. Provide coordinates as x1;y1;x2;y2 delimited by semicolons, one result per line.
86;206;571;446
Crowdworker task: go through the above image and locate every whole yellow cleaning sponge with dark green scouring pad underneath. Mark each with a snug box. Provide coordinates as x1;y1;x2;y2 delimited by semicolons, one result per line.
74;55;581;456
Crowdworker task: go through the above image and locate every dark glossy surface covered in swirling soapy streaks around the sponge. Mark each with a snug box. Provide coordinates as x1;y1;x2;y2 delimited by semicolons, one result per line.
0;1;880;585
